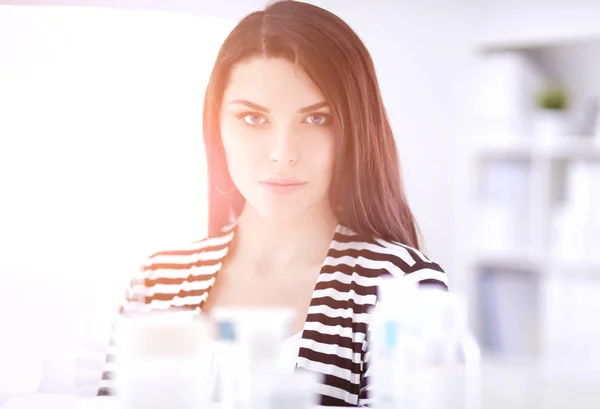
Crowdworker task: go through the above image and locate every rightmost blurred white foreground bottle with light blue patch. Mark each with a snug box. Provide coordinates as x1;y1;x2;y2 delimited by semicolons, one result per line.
370;280;481;409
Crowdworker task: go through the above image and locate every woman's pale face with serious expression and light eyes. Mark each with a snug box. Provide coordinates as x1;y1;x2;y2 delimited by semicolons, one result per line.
220;57;334;219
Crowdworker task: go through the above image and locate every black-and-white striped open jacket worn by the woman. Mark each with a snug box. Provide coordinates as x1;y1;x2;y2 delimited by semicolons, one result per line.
98;224;447;406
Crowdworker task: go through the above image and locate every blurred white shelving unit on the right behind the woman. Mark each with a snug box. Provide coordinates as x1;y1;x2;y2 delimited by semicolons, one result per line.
457;10;600;370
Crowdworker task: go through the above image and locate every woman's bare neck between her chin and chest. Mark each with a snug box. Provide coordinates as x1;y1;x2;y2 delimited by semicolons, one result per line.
233;205;338;272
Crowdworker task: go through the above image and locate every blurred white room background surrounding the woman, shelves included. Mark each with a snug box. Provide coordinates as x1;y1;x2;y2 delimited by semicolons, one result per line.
0;0;600;401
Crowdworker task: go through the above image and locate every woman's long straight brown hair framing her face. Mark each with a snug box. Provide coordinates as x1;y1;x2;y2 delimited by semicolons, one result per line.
204;1;419;248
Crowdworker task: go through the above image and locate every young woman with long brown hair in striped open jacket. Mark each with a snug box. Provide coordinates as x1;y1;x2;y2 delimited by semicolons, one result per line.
99;1;447;406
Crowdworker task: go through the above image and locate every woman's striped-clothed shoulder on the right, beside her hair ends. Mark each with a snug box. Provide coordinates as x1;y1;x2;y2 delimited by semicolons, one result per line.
334;226;448;289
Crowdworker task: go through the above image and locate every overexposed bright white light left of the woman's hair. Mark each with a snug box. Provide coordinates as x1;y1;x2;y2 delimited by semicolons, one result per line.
0;6;235;292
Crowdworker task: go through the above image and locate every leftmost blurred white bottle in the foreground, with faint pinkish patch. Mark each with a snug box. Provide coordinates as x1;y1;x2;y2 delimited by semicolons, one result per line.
115;311;212;409
